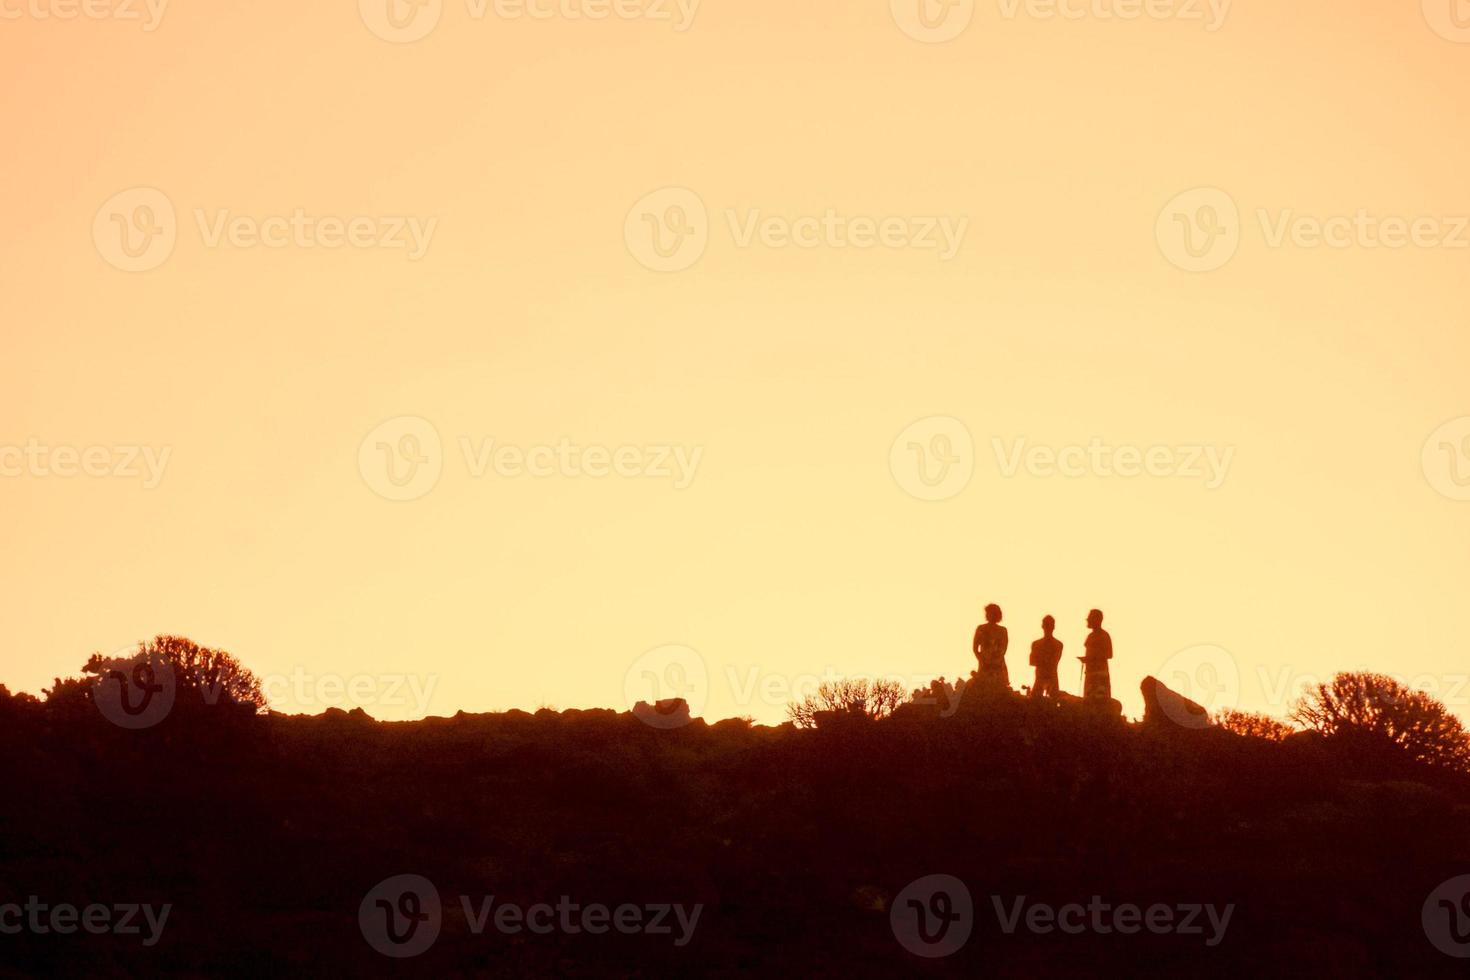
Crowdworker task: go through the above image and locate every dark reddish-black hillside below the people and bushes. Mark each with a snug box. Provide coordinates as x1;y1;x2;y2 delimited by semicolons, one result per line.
0;687;1470;977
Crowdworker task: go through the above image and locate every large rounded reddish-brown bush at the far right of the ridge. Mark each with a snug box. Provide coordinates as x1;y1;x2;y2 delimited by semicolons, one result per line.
1291;673;1470;771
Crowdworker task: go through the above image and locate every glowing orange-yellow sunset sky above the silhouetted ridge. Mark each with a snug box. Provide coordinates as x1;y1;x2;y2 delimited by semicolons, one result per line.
0;0;1470;723
